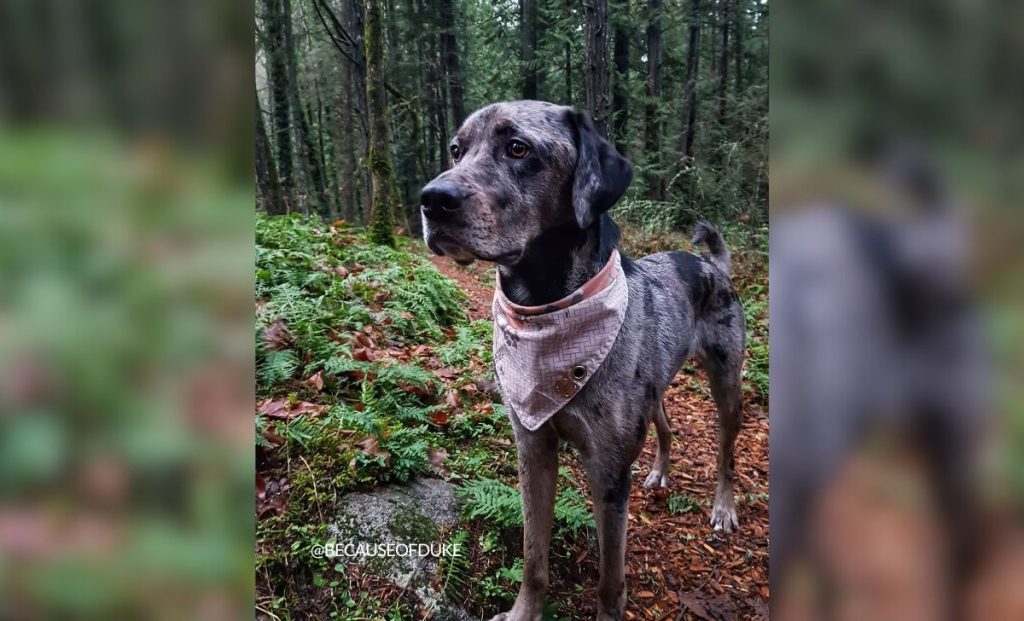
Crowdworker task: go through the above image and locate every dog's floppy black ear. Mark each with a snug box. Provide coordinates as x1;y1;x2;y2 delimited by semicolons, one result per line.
567;110;633;229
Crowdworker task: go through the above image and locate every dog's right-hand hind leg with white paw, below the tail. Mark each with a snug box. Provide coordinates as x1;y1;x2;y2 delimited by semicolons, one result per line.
701;346;742;533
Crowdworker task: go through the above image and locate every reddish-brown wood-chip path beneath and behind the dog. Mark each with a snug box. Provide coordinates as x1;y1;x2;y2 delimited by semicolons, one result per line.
431;256;769;620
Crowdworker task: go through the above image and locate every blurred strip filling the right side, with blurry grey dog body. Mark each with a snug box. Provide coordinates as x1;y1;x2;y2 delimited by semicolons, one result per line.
770;2;1024;620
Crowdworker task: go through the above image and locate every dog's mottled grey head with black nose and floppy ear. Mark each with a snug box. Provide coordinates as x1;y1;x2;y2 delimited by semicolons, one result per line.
420;101;633;265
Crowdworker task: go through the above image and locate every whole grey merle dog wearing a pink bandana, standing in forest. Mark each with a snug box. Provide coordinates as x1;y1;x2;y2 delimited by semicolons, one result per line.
421;100;745;621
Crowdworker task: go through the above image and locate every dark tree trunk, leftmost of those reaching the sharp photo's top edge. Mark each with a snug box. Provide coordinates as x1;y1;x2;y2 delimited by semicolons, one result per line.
263;0;295;212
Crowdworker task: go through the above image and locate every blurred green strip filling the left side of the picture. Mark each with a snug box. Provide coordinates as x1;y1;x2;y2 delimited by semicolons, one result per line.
0;1;253;619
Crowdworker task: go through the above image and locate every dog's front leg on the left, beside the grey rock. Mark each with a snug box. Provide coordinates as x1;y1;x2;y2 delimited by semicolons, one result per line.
492;416;558;621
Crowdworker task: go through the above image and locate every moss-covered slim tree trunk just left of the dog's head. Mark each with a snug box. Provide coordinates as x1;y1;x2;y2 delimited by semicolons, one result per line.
365;0;396;246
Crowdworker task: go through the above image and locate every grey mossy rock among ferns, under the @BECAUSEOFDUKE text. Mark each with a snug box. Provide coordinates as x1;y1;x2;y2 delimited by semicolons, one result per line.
328;479;474;621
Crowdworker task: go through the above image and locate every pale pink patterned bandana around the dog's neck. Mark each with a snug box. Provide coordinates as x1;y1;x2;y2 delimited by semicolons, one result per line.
492;250;629;431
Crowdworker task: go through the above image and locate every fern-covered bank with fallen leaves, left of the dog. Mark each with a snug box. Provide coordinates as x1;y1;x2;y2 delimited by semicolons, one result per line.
254;215;515;619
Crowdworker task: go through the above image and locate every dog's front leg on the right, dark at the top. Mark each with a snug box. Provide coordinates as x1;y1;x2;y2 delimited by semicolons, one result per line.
584;454;632;621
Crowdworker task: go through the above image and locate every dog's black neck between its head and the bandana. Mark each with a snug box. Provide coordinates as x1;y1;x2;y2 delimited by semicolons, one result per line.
498;213;618;306
